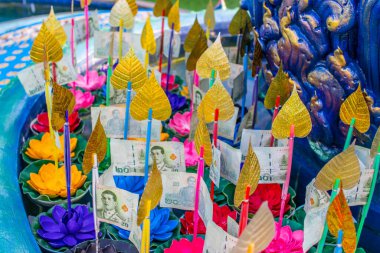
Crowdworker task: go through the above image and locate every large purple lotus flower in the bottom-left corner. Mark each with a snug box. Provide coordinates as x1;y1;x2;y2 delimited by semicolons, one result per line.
37;205;95;248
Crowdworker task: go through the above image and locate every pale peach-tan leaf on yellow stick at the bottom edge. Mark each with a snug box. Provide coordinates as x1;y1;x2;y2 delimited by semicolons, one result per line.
231;201;275;253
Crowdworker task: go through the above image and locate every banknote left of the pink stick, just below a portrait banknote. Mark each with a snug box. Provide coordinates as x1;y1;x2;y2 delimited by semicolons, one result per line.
160;172;197;210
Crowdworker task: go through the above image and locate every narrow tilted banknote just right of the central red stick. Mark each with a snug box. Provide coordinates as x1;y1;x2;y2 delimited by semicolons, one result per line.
219;141;241;185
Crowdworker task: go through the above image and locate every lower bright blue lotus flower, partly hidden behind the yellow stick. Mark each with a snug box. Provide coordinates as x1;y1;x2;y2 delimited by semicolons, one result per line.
114;207;179;241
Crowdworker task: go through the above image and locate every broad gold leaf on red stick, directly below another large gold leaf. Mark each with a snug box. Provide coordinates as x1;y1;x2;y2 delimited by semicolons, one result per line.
197;78;235;123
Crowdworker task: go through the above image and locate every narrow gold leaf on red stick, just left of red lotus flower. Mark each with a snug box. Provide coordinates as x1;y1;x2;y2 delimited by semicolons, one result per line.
234;142;260;208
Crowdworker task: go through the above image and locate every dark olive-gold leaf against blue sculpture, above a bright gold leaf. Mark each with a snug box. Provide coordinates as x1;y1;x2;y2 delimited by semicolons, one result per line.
264;63;294;109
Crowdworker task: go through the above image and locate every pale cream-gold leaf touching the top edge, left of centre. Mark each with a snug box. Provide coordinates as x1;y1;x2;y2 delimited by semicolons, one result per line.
110;0;134;29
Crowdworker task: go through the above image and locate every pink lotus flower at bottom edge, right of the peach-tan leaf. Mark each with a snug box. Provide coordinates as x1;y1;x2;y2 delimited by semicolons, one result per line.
263;222;303;253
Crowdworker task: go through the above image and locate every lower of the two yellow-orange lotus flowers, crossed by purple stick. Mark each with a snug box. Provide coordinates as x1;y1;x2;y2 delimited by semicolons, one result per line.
27;163;87;198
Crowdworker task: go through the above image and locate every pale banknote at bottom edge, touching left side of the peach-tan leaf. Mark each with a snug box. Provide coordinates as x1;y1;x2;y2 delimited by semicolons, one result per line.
203;221;238;253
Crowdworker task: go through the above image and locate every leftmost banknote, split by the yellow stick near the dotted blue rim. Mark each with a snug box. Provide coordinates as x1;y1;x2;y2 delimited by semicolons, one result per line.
17;54;78;96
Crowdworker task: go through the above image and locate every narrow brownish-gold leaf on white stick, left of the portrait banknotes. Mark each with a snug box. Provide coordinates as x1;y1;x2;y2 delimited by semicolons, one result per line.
82;114;107;174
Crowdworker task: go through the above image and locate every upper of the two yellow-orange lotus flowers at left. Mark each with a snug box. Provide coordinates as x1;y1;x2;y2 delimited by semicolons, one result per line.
25;133;78;161
